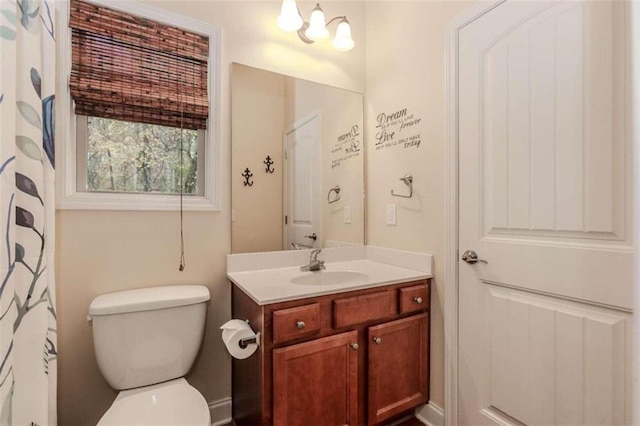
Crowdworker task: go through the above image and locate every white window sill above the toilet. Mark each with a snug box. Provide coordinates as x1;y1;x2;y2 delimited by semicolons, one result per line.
56;192;220;211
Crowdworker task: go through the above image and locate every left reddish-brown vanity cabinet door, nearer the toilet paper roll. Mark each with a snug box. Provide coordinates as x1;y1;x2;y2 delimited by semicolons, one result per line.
273;331;358;426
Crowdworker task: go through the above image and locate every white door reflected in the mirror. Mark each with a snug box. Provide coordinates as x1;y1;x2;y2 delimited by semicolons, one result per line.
284;114;321;250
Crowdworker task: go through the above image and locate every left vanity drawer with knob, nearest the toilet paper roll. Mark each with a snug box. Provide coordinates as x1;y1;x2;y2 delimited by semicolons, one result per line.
273;303;320;343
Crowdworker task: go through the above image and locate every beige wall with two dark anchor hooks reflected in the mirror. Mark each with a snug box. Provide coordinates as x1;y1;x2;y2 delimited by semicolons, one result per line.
231;64;285;253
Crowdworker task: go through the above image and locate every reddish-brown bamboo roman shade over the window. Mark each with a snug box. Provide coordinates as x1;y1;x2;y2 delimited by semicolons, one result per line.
69;0;209;129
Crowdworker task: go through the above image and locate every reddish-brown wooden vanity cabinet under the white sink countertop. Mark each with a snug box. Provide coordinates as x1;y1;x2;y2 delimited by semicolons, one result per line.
232;279;430;426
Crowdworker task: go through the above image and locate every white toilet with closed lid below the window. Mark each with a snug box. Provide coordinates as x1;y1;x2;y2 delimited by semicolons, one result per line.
89;285;211;426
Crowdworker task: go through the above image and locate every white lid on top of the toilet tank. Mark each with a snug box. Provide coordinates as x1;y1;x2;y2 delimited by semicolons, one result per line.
89;285;210;316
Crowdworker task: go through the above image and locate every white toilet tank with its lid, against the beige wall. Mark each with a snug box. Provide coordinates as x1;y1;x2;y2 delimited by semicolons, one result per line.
89;285;210;390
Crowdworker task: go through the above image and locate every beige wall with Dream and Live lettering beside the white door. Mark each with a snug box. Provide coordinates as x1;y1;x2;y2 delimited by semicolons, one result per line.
365;1;470;407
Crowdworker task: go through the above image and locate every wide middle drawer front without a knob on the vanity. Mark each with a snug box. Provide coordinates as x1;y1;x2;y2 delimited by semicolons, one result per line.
333;291;397;328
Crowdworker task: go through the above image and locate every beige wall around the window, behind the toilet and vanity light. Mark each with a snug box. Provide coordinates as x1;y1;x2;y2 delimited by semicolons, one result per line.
56;1;365;425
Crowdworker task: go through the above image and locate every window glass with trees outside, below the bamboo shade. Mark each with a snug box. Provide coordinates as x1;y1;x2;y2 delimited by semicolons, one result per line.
76;116;205;195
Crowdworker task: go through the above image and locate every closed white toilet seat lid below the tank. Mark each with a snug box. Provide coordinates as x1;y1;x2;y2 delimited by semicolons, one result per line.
98;378;211;426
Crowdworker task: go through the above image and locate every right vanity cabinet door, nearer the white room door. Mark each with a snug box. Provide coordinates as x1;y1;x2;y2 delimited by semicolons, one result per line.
368;314;429;424
